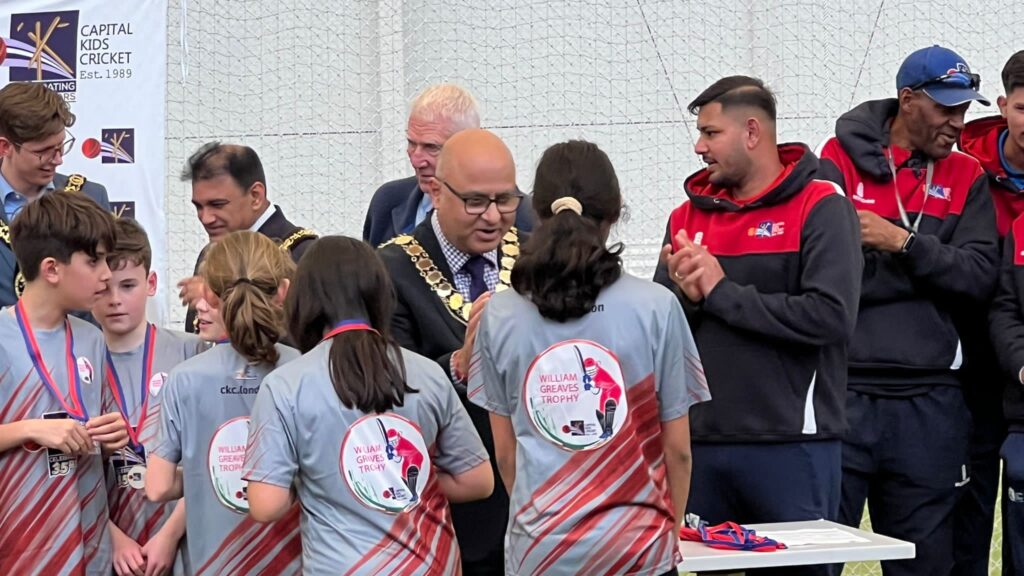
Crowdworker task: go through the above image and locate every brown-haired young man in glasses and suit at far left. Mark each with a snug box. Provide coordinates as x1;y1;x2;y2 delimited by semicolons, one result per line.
0;82;111;306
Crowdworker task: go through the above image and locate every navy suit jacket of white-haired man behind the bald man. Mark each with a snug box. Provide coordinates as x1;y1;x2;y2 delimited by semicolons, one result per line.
362;176;534;246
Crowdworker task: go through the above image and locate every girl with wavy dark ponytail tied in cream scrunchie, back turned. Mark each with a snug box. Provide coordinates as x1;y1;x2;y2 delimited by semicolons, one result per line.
469;140;709;576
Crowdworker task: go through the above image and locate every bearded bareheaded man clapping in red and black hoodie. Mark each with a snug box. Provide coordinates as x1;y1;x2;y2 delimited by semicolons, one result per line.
654;77;862;575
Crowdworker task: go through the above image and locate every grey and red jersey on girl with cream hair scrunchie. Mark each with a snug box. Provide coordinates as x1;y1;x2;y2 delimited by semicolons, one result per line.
469;275;710;575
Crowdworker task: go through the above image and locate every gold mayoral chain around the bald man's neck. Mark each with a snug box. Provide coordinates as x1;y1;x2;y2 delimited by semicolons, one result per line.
384;228;519;323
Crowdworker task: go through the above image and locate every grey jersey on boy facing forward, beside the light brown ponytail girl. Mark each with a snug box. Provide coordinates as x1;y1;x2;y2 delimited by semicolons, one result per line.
103;327;207;574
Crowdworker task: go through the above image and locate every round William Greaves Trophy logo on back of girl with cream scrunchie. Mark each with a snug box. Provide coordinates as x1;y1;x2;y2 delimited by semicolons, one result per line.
523;340;629;450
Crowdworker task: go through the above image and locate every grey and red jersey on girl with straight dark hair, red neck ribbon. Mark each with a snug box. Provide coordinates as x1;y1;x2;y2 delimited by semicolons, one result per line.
245;341;487;575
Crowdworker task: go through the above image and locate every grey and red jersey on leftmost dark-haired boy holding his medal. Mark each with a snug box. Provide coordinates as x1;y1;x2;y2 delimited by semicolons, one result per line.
0;307;112;576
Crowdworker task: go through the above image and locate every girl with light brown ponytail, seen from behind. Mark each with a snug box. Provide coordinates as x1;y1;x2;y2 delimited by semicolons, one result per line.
145;231;302;575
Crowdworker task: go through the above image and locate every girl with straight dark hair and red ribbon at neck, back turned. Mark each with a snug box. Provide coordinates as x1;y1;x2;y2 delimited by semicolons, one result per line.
244;236;494;574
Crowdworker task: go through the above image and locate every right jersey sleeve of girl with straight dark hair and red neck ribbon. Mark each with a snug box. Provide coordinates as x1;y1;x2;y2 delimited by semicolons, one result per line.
433;375;487;475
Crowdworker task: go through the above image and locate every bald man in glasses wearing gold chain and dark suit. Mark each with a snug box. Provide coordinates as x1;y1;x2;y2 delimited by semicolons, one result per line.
379;129;523;574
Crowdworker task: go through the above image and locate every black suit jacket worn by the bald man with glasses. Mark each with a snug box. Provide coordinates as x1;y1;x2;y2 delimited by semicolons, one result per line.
378;219;509;562
